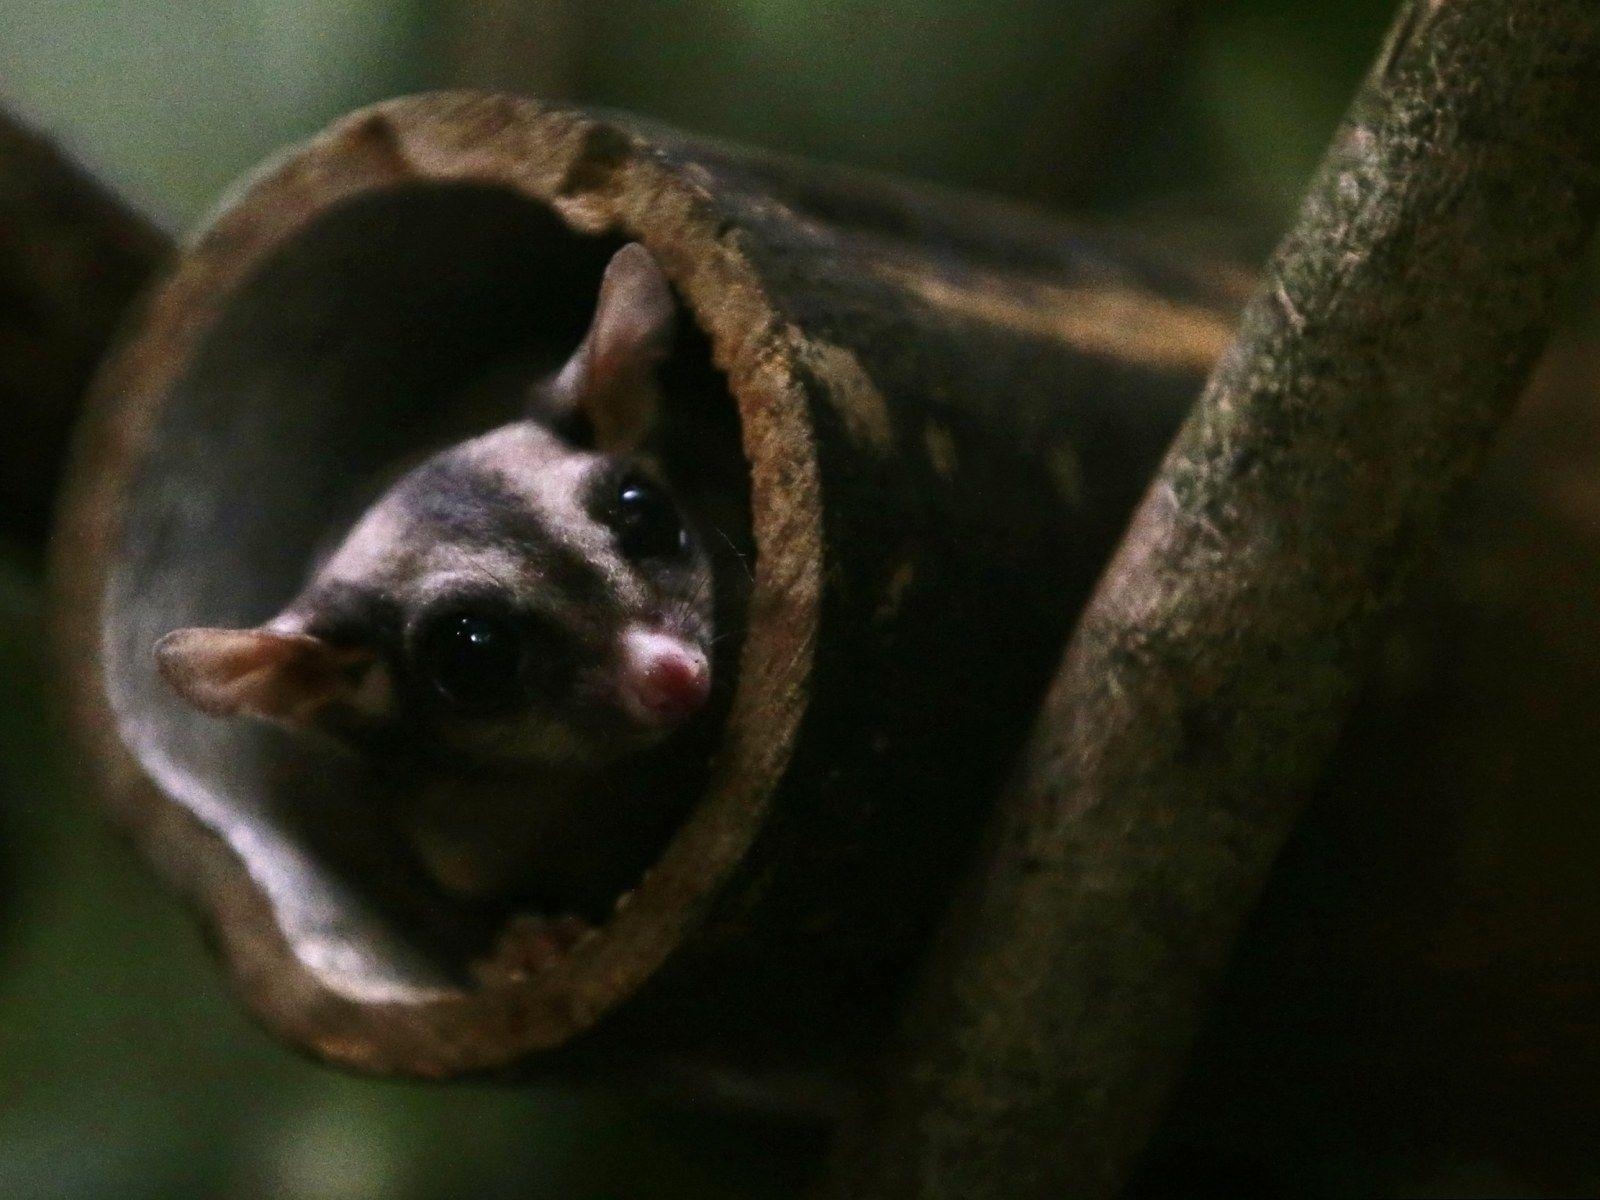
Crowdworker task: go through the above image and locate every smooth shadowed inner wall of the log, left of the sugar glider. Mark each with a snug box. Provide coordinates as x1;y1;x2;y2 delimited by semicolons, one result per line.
106;184;662;1000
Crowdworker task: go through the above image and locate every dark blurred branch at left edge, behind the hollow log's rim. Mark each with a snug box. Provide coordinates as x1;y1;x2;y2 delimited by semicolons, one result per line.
0;110;171;549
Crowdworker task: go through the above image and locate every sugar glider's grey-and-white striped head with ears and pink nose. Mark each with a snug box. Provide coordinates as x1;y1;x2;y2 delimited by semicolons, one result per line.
157;245;712;766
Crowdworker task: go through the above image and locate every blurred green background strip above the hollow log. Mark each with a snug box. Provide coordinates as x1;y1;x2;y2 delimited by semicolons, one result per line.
0;0;1394;226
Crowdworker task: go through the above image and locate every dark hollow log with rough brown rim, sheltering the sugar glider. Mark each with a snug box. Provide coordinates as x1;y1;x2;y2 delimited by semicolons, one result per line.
54;93;1240;1091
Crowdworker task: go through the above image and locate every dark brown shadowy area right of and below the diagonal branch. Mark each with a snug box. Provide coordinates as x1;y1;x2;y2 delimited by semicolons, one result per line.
1128;334;1600;1200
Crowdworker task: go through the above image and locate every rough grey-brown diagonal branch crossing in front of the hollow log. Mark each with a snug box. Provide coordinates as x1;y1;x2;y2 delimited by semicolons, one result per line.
830;0;1600;1200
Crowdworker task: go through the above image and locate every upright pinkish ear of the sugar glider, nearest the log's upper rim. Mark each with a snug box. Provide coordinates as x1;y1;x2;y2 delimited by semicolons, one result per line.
544;242;677;451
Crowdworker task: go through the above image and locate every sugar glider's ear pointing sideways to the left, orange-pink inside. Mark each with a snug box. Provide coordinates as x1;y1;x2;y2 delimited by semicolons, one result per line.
155;629;371;725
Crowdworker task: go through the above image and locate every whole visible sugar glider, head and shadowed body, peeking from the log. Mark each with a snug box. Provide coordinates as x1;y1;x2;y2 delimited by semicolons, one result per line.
155;243;749;910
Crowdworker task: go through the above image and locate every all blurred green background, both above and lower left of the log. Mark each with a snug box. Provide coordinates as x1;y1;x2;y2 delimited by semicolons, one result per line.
0;0;1392;1200
